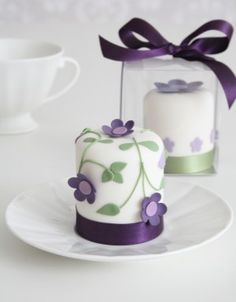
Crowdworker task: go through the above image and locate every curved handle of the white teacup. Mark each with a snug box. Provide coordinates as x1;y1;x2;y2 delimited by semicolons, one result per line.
44;57;80;102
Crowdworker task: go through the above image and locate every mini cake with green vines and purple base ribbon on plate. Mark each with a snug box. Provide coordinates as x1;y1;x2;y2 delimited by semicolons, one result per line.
68;119;167;245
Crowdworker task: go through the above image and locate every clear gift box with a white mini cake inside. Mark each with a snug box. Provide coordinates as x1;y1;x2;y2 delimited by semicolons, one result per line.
120;58;219;175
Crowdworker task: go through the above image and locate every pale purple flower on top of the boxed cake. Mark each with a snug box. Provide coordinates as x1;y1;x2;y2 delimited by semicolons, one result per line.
154;79;203;93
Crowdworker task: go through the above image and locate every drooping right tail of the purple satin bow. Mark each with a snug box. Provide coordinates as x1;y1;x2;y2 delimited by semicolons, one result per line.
201;59;236;109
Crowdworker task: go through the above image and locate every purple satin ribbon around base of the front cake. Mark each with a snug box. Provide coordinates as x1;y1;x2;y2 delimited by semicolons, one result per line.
75;211;164;245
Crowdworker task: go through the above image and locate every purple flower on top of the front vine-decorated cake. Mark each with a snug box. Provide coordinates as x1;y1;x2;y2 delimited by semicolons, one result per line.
102;119;134;137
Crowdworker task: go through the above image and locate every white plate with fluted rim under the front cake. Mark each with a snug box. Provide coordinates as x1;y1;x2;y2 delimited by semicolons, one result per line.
6;179;232;261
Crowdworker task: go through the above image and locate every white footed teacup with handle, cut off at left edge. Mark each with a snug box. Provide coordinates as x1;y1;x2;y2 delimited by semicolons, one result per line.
0;39;80;134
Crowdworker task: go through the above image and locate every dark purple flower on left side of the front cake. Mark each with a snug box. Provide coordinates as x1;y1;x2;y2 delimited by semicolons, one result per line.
68;174;96;203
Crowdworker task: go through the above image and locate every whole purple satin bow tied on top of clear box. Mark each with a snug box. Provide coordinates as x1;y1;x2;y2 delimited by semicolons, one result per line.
99;18;236;108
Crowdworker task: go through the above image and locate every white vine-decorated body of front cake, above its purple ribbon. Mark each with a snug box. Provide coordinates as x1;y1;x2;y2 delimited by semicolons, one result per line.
69;120;165;224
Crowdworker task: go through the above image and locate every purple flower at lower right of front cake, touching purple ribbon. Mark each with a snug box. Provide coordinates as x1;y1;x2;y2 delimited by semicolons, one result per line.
141;193;167;225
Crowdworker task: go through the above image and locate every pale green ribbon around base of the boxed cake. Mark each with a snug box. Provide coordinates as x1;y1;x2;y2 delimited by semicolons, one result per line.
165;149;215;174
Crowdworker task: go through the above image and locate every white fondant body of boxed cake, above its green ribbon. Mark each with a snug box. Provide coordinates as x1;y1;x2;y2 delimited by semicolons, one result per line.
144;84;215;157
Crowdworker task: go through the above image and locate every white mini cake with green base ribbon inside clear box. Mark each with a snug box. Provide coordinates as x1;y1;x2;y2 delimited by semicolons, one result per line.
144;80;215;173
